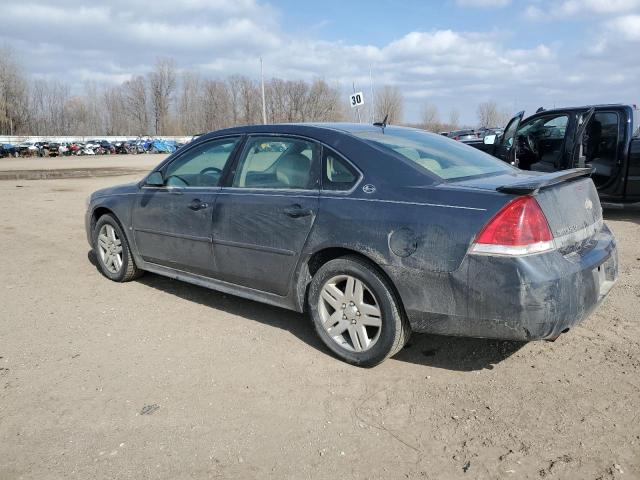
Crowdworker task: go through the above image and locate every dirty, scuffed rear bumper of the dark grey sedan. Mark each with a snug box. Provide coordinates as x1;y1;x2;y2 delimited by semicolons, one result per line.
390;225;618;341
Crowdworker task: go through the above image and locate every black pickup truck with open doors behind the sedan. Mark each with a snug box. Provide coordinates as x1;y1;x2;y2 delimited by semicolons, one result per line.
466;105;640;205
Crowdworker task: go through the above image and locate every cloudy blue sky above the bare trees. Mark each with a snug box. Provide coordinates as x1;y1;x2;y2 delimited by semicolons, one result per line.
0;0;640;125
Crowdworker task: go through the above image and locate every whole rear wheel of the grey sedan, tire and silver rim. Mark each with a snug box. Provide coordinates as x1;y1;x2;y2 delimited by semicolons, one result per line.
307;256;411;367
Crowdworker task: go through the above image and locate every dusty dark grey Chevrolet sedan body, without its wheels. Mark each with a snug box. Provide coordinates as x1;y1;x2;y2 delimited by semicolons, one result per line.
86;124;618;348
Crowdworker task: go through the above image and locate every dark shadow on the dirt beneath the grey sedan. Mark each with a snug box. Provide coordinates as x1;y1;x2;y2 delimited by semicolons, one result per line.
87;250;525;371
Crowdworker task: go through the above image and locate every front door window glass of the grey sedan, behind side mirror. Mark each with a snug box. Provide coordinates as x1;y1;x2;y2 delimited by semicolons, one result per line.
164;137;239;187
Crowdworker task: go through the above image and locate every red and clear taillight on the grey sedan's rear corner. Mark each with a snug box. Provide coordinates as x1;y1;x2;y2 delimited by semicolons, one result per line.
471;196;555;255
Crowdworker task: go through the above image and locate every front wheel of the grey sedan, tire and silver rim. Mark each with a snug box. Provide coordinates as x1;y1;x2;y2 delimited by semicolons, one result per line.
93;214;143;282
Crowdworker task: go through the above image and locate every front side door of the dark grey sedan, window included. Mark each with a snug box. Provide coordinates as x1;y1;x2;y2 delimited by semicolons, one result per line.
132;136;240;276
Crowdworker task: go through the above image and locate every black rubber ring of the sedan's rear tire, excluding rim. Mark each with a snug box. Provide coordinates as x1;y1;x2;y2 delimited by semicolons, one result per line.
308;258;402;367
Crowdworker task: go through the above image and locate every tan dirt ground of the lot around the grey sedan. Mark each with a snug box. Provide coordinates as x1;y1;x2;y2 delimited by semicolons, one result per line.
0;157;640;480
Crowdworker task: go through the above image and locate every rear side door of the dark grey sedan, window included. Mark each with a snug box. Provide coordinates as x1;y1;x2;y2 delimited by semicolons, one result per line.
213;135;320;295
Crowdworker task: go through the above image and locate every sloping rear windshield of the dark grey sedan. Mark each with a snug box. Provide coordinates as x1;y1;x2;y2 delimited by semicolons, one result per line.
354;128;514;180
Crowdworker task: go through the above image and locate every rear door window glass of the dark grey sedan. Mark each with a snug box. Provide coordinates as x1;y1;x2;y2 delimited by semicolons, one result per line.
233;137;319;190
